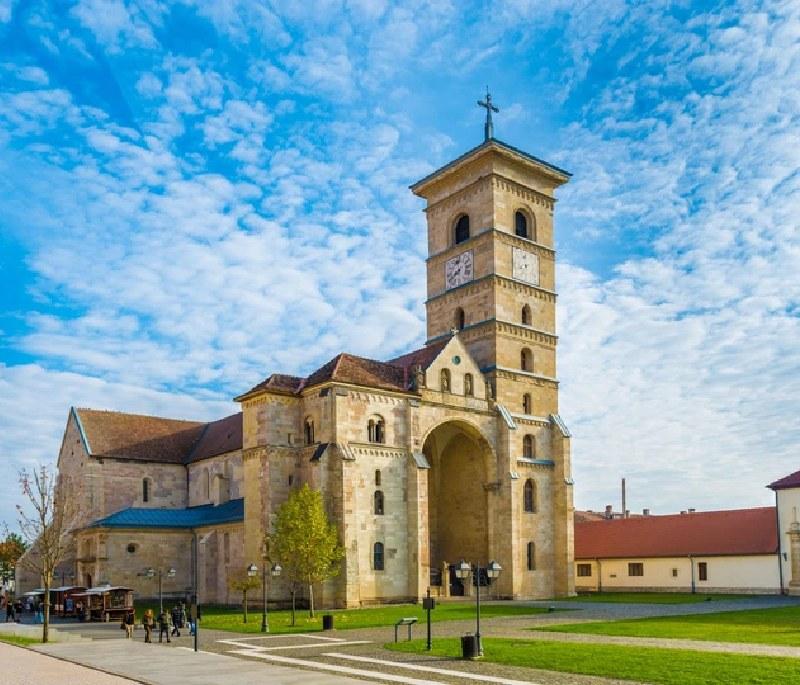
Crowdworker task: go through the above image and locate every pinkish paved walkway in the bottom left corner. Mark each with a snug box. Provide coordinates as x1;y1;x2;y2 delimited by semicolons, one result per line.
0;642;137;685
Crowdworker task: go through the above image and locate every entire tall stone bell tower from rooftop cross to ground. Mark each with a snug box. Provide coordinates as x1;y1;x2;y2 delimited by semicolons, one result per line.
411;111;574;598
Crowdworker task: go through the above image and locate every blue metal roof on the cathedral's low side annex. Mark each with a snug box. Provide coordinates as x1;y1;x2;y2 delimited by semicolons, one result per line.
90;499;244;528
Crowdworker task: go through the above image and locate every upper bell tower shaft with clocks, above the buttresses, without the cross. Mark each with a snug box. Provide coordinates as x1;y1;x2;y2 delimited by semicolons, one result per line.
411;138;570;416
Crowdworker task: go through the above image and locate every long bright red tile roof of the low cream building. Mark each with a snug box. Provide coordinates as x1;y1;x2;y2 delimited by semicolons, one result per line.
575;507;778;559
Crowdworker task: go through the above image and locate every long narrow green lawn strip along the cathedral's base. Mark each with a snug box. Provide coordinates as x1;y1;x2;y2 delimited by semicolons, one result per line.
136;602;547;633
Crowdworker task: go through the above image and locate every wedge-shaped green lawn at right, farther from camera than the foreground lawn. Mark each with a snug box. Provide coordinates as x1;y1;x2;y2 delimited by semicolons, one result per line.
535;606;800;647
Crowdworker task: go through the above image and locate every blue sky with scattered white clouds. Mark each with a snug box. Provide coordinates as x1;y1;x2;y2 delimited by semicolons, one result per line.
0;0;800;521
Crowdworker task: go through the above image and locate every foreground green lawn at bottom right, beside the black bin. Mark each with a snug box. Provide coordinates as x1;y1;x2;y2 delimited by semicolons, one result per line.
386;638;800;685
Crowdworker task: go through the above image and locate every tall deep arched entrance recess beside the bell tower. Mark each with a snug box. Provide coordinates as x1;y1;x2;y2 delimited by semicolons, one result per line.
423;421;491;594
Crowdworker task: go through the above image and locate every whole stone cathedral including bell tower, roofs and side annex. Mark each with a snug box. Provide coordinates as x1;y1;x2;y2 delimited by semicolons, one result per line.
18;117;574;607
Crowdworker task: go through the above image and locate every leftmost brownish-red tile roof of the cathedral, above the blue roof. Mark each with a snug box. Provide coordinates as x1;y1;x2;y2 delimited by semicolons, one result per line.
75;409;206;464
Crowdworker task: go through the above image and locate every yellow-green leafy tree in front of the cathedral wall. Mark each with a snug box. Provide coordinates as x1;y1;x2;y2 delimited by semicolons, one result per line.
270;485;344;625
